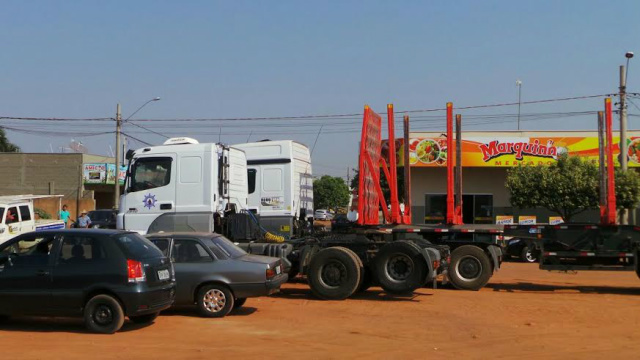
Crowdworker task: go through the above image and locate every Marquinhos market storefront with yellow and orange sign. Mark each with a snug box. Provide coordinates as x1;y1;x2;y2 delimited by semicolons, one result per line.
396;131;640;224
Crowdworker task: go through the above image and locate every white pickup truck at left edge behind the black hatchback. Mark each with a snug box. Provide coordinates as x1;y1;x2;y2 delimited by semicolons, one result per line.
0;195;64;244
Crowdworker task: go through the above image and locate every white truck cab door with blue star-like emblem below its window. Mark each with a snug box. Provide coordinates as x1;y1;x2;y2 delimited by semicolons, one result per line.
120;153;177;234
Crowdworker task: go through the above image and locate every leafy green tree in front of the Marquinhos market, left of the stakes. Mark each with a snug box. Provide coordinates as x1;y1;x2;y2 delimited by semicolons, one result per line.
506;156;599;222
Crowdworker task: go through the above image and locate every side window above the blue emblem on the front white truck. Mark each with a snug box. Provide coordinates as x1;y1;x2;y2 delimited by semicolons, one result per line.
128;157;173;192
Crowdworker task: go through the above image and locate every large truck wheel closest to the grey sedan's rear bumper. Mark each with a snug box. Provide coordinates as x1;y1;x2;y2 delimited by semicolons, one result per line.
308;246;361;300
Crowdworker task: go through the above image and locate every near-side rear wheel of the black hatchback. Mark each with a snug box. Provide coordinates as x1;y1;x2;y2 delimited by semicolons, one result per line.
84;295;124;334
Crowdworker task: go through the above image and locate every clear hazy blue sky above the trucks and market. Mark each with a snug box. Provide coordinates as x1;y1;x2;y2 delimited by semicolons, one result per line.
0;0;640;176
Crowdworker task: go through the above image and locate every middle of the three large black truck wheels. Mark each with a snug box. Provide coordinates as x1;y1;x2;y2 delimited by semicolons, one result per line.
373;240;428;294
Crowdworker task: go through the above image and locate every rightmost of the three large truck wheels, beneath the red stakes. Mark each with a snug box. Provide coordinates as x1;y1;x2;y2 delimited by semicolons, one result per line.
449;245;492;290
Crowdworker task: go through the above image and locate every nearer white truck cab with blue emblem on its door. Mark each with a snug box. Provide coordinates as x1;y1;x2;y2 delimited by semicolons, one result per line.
117;137;247;234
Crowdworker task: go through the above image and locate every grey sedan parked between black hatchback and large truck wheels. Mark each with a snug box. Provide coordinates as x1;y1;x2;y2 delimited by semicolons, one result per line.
147;233;288;317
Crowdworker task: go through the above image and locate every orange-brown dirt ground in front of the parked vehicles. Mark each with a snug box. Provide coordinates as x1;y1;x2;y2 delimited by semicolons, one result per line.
0;263;640;359
